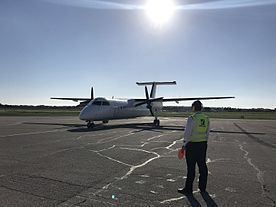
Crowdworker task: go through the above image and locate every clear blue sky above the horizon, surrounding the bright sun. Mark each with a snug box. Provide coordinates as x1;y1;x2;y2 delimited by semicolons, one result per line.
0;0;276;109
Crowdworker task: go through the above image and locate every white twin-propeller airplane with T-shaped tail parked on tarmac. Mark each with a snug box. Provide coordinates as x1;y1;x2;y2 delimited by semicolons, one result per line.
51;81;235;128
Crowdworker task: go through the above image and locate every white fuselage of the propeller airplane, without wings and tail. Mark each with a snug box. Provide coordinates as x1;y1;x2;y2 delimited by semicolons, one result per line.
79;98;162;121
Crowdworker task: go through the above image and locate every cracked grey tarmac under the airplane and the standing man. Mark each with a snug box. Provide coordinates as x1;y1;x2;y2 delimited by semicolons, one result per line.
0;117;276;207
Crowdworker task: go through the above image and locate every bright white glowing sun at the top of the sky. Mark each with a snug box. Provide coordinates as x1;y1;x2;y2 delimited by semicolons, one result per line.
145;0;176;26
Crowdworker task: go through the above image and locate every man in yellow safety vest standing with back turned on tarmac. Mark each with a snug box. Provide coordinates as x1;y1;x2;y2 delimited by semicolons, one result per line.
178;101;210;196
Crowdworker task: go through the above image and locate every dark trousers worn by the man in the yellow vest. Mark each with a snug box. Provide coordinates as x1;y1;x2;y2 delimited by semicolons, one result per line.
185;142;208;192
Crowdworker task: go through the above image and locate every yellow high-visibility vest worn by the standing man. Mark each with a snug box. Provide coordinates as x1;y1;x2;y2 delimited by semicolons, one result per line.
190;112;209;142
